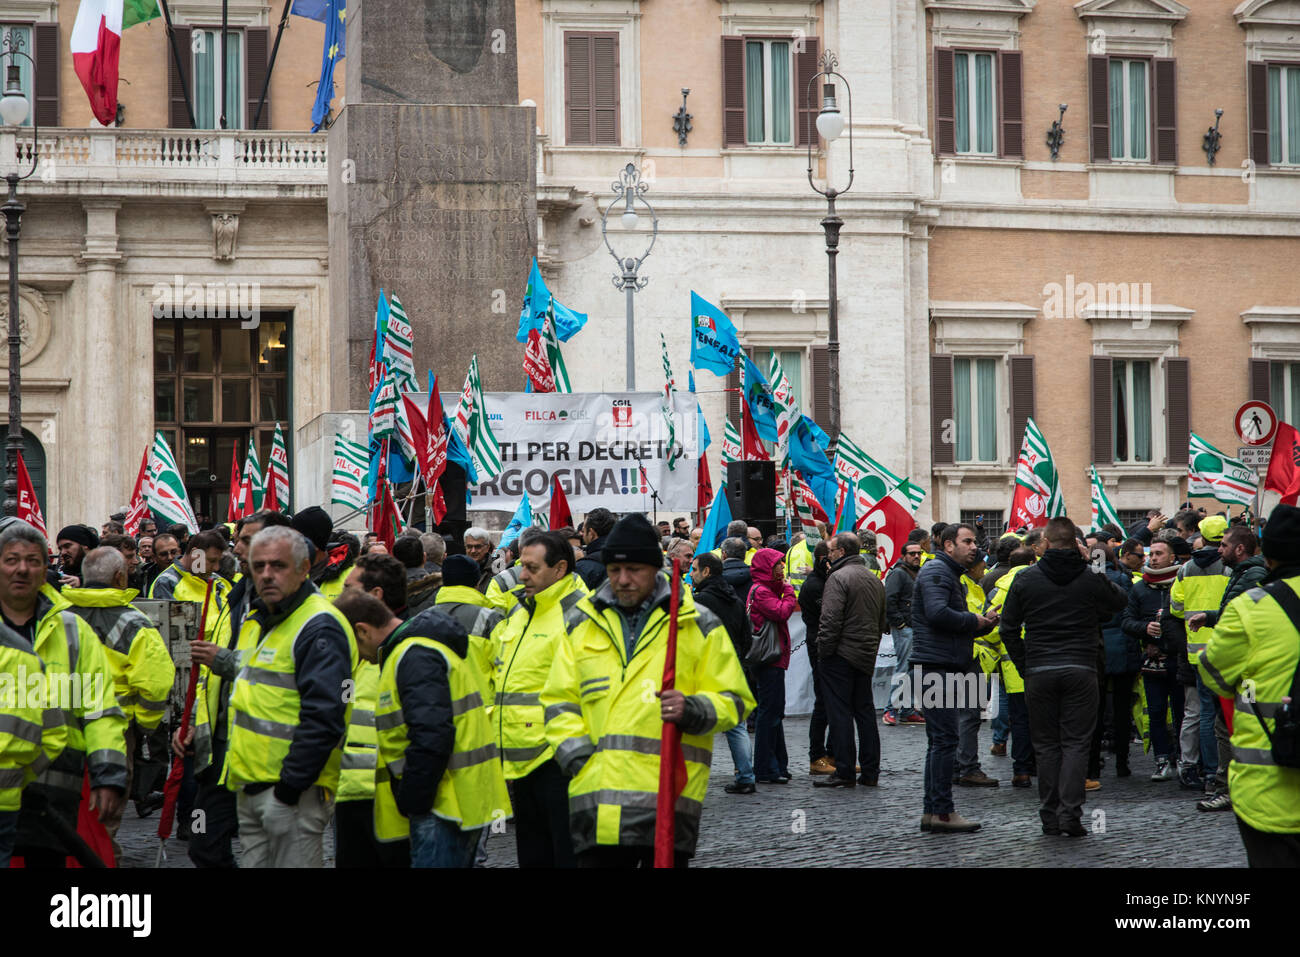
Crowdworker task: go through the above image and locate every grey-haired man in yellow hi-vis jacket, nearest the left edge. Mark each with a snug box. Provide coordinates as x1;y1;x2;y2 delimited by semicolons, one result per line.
0;518;126;867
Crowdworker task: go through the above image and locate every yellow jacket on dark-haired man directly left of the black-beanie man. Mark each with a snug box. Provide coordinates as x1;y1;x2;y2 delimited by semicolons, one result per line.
493;575;586;781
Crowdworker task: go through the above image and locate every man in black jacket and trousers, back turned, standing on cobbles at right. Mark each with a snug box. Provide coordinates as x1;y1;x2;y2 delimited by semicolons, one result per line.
1000;518;1125;837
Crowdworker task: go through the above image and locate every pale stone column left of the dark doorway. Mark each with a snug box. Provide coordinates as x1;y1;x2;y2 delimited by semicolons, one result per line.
79;199;123;520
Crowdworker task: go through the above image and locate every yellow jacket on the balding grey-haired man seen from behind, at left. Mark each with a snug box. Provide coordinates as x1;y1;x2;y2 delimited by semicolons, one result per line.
61;588;176;731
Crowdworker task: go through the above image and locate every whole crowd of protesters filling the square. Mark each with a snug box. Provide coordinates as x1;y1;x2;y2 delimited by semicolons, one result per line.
0;506;1300;867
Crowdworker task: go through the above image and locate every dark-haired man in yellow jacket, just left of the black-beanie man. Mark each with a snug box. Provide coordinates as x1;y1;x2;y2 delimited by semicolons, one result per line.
493;532;586;867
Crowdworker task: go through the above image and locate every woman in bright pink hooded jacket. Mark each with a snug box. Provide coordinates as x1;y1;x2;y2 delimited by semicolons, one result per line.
748;549;800;784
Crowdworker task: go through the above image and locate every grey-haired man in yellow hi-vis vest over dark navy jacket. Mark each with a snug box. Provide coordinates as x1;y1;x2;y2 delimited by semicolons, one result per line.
221;527;359;867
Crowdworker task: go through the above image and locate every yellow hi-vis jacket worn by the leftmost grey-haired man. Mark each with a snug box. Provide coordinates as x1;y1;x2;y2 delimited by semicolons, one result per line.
30;585;126;802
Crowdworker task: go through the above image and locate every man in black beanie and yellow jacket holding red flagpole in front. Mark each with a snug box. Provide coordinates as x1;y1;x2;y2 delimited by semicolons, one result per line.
541;514;754;867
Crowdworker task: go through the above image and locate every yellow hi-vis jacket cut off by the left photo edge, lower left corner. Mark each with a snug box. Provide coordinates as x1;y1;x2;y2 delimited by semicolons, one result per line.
0;625;68;811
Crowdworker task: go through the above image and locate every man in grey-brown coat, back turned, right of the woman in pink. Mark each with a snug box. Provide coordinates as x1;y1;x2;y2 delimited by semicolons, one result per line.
813;532;887;788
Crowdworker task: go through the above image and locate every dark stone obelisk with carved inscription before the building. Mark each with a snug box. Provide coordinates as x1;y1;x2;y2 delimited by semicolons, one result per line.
329;0;537;408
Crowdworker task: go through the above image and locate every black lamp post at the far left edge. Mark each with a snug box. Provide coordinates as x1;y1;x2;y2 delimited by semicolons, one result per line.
0;33;38;515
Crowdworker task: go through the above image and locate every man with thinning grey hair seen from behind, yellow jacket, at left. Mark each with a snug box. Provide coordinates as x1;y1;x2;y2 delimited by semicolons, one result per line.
61;545;176;857
